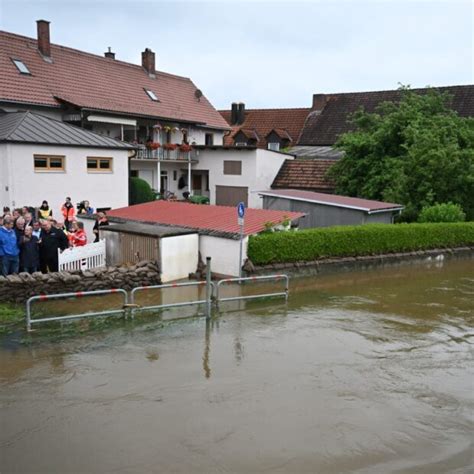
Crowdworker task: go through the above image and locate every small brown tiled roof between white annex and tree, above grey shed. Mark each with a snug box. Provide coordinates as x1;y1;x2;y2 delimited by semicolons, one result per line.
271;158;335;192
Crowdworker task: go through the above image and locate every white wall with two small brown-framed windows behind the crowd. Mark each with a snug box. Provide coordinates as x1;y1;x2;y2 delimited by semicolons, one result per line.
0;144;128;217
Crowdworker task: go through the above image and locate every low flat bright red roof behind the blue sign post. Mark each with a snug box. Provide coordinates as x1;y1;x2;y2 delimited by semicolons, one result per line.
107;201;304;239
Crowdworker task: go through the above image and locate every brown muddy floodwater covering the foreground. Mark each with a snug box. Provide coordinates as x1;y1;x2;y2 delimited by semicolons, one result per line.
0;260;474;473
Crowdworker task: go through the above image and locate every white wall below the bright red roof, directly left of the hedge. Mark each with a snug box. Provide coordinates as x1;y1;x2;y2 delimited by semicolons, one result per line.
199;235;248;276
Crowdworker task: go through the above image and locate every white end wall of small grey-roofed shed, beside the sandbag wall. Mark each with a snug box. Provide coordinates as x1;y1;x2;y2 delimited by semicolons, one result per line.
160;234;199;283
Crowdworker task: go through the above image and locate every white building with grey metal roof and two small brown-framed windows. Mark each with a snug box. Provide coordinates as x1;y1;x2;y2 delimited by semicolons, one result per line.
0;112;134;216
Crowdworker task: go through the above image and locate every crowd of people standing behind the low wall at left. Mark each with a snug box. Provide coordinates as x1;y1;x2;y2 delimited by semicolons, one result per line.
0;197;108;276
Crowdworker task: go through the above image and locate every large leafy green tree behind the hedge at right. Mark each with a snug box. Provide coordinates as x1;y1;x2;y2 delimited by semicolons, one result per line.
329;87;474;221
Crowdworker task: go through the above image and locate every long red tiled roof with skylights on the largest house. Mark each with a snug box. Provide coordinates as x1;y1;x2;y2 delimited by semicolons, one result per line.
0;32;229;129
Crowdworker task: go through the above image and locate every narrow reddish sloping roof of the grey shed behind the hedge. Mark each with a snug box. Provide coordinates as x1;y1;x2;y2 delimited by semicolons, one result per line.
258;189;404;214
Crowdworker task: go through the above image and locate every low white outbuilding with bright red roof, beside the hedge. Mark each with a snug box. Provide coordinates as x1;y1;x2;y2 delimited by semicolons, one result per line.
106;201;304;276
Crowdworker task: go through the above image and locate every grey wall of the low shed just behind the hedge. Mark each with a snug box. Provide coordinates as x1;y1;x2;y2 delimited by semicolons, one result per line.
263;196;392;229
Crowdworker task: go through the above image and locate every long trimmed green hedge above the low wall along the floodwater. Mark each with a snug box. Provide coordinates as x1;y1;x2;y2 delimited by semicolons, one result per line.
248;222;474;265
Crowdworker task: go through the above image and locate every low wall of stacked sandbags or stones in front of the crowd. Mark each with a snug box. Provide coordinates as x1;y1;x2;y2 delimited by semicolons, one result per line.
0;261;160;303
